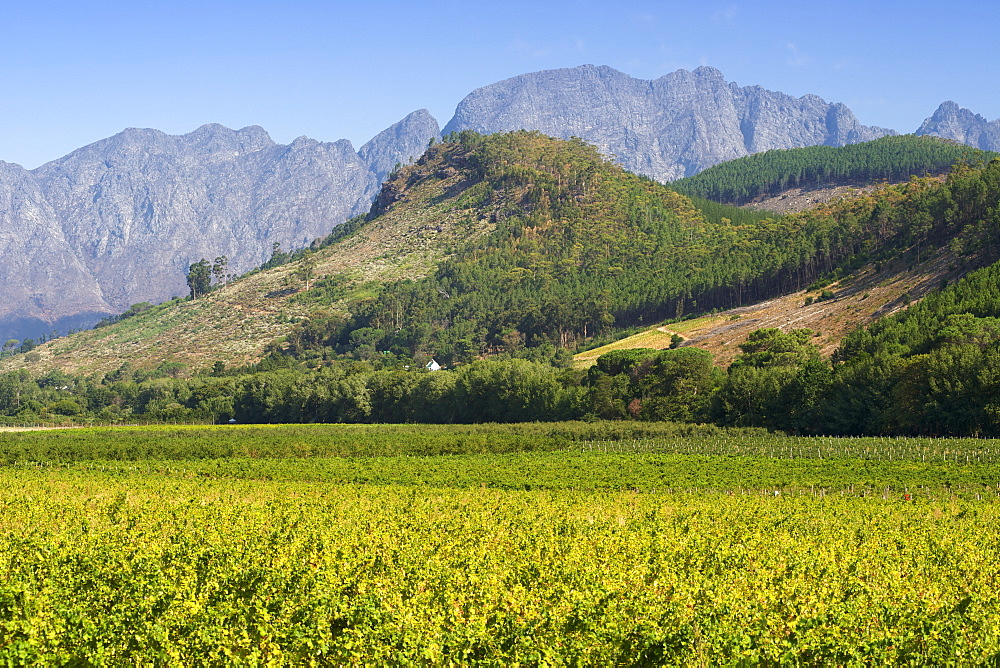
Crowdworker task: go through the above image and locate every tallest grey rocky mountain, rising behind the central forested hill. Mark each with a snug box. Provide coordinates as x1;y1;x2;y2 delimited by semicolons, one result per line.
443;65;895;181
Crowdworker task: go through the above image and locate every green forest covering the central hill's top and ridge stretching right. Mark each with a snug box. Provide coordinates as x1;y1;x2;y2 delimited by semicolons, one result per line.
283;132;1000;363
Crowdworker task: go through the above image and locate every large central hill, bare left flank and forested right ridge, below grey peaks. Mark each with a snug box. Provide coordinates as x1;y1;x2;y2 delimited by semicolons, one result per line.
9;132;1000;375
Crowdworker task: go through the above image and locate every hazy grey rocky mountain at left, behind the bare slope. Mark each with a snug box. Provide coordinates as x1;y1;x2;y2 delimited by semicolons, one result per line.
0;110;438;339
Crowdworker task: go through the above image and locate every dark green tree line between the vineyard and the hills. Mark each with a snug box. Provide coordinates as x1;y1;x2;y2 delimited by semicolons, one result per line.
0;248;1000;437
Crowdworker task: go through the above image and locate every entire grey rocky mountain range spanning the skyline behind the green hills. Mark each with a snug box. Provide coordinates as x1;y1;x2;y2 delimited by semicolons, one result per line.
0;65;1000;340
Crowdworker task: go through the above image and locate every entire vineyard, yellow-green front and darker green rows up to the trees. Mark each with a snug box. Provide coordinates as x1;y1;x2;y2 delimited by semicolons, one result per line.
0;423;1000;665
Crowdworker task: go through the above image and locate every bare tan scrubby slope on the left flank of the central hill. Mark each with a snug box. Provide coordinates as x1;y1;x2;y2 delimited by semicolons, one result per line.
0;153;490;374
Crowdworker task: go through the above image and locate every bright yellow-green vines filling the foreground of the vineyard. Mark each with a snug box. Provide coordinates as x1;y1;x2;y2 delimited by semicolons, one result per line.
0;470;1000;666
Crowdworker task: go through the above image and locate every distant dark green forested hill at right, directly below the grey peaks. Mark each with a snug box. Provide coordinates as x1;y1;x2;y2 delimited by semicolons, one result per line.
672;135;996;205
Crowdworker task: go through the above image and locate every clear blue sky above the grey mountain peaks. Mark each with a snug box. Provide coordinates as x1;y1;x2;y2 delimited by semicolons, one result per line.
0;0;1000;168
